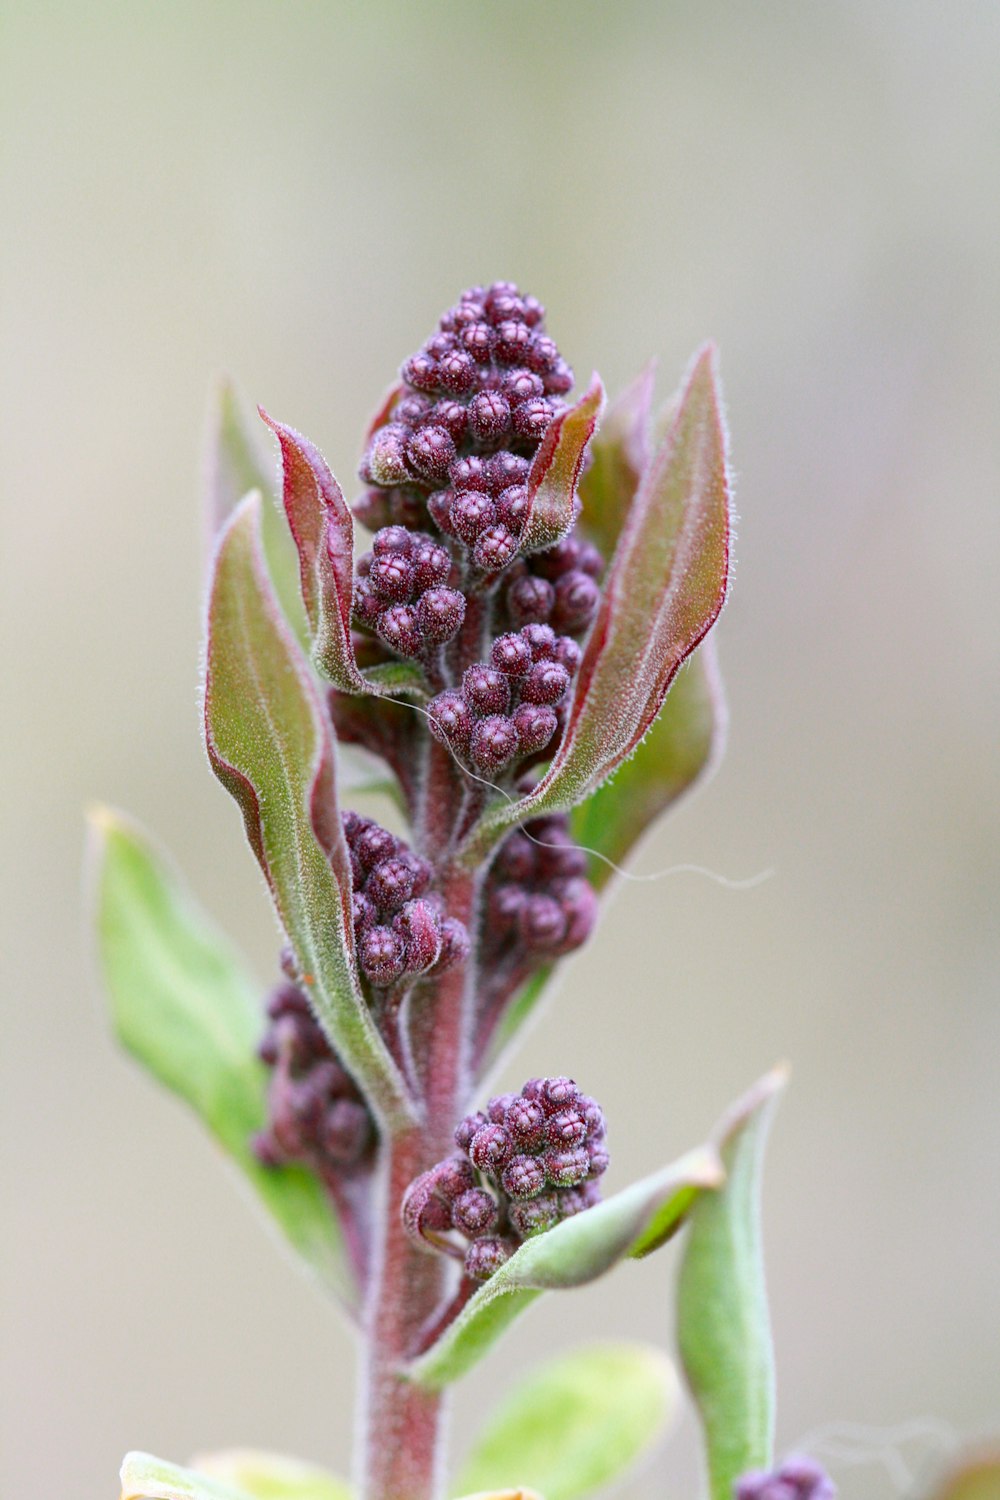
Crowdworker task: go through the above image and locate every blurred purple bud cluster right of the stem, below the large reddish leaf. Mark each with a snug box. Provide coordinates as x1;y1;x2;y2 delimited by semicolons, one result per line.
481;813;597;965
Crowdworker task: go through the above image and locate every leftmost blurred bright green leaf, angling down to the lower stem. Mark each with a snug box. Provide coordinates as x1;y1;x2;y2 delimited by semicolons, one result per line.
90;807;358;1305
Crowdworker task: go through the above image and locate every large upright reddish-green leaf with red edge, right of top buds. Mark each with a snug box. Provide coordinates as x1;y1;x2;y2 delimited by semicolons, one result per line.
463;348;730;864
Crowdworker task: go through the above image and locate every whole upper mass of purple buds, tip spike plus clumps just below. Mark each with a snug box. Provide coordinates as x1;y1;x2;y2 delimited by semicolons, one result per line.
347;282;604;777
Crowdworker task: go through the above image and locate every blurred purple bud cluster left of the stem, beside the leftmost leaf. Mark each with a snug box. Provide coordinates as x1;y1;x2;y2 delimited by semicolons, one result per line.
253;980;375;1176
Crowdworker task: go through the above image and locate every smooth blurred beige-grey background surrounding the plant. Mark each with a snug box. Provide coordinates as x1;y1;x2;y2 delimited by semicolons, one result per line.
0;0;1000;1500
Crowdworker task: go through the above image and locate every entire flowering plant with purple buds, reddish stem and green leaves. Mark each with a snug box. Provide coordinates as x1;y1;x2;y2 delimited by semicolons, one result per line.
94;282;983;1500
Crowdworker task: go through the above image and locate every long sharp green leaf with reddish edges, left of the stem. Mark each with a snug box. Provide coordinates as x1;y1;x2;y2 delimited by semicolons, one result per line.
204;497;411;1125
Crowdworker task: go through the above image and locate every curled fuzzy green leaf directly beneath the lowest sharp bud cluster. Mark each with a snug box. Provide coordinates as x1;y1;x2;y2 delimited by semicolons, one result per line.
408;1146;723;1389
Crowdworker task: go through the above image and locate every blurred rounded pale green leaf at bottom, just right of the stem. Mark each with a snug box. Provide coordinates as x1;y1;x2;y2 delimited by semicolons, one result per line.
460;1344;678;1500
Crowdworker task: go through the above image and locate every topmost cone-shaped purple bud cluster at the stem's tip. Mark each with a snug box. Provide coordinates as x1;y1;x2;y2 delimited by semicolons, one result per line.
355;282;573;555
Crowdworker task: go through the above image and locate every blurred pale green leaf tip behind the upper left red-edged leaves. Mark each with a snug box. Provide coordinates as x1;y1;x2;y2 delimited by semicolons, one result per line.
205;378;309;647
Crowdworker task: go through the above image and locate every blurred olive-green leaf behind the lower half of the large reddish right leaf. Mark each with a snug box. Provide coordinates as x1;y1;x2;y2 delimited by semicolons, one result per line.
571;636;726;891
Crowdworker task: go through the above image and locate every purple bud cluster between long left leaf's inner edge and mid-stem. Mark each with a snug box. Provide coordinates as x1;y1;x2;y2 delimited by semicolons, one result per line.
342;813;469;989
